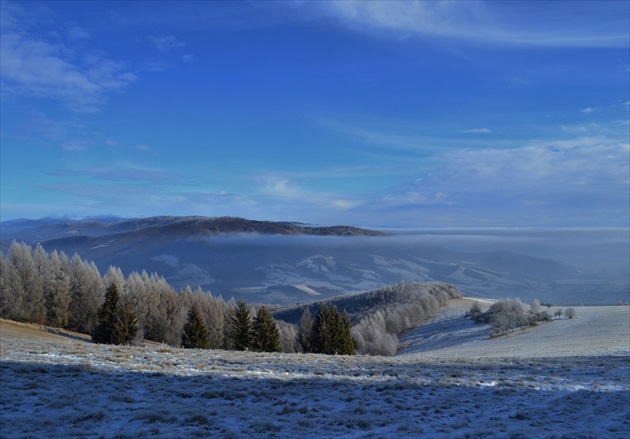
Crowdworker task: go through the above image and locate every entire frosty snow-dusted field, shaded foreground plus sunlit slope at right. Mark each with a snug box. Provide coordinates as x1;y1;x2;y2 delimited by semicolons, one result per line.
0;303;630;438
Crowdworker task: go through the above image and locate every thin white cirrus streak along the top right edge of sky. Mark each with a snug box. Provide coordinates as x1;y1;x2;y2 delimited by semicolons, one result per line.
319;0;629;47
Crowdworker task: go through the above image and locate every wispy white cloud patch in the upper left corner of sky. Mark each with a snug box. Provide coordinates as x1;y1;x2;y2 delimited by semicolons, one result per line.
0;2;136;113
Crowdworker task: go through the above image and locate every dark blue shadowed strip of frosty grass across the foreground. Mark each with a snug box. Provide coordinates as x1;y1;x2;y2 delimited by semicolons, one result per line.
0;357;630;438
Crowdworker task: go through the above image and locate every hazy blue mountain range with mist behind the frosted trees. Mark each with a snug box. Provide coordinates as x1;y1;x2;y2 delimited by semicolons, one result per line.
1;216;628;304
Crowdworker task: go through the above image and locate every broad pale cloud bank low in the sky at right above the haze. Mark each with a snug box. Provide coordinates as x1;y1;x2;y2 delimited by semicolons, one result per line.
376;136;630;227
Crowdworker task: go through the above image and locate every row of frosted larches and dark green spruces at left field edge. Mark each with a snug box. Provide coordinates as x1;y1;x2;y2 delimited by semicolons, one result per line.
0;242;355;354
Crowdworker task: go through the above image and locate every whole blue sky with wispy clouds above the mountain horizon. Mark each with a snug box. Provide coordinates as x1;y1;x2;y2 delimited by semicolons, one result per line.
0;1;630;227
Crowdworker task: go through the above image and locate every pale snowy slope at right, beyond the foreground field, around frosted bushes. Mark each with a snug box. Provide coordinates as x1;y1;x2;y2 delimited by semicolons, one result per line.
397;299;630;358
